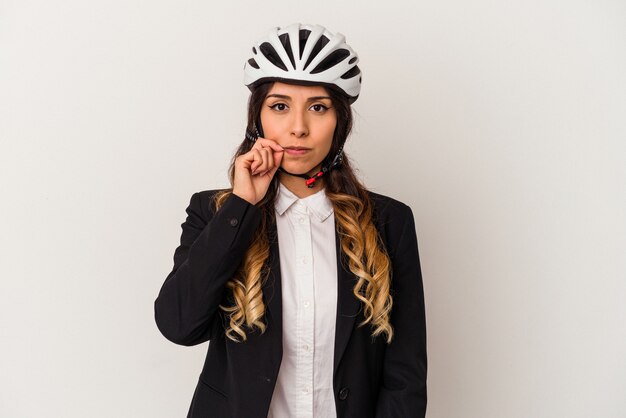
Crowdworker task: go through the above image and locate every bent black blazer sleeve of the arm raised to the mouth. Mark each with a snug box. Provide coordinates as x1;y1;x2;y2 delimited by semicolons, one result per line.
154;192;261;346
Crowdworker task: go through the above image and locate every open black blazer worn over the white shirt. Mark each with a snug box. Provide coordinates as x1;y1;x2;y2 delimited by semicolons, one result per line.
154;190;427;418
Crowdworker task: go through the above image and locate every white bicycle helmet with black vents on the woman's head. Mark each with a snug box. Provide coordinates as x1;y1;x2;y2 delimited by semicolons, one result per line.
244;23;361;103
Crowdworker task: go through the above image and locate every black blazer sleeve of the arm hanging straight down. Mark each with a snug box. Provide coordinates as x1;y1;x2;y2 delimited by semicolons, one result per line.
376;205;427;418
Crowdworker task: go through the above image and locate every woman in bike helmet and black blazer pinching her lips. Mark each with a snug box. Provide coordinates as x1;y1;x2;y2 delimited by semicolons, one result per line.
155;24;427;418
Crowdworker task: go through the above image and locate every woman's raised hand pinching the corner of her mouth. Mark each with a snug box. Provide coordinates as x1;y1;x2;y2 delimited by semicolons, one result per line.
233;138;284;205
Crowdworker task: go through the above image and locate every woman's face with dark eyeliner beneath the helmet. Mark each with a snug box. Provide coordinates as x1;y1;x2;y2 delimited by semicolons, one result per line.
261;82;337;174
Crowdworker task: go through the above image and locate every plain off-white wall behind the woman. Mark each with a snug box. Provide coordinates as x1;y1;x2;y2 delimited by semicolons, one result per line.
0;0;626;418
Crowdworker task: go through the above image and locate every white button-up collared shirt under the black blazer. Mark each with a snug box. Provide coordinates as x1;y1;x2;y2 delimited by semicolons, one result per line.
268;183;337;418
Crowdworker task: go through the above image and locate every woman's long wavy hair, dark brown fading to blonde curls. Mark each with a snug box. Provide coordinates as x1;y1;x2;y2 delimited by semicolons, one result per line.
214;83;393;343
